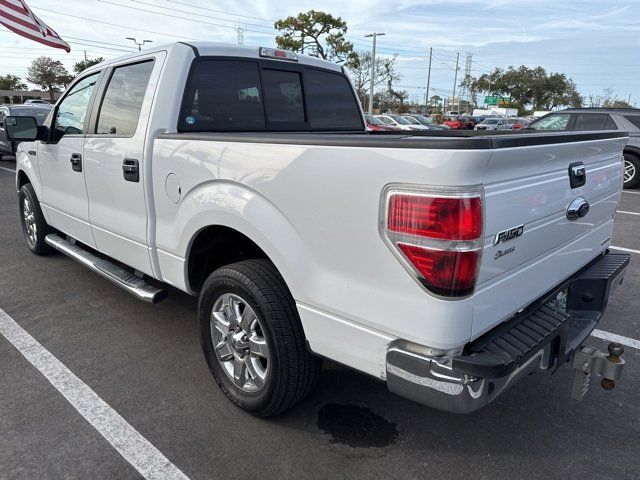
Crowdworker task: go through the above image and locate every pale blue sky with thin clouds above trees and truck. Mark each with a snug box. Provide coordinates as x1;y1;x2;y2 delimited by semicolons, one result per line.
0;0;640;106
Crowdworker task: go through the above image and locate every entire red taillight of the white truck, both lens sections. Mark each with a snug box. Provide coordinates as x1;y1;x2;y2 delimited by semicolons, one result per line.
385;189;482;297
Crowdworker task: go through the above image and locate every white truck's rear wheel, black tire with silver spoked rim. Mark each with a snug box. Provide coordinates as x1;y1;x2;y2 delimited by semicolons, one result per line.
198;260;322;417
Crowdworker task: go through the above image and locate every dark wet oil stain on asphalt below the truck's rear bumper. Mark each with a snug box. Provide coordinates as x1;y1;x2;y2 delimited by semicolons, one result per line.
318;403;398;448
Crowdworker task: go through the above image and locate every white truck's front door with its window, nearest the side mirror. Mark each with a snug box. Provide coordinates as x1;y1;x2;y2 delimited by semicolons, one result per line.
38;73;100;247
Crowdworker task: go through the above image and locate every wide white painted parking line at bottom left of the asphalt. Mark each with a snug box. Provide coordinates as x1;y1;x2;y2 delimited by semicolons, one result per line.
0;309;188;480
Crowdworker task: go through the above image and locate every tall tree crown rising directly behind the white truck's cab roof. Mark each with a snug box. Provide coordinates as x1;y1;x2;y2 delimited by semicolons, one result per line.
274;10;357;66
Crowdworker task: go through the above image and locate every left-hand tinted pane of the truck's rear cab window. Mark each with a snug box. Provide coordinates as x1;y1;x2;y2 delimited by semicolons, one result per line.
178;60;265;132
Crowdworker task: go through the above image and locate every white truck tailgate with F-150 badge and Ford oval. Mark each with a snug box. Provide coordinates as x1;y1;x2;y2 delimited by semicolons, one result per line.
472;133;627;338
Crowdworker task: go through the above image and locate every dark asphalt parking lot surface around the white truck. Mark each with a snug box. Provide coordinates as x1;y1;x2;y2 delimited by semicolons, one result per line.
0;155;640;479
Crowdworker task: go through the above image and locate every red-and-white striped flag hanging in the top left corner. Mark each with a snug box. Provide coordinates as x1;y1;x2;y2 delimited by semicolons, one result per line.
0;0;71;52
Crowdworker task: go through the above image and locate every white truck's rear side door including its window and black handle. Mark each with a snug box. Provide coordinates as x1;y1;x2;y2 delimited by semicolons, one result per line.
84;56;159;275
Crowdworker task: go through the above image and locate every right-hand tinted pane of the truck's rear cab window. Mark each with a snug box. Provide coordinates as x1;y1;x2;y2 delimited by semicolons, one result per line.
305;68;363;130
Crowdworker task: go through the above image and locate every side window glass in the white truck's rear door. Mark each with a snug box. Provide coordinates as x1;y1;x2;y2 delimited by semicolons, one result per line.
96;61;153;137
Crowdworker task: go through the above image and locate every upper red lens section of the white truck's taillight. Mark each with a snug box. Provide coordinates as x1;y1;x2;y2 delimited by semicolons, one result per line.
388;194;482;240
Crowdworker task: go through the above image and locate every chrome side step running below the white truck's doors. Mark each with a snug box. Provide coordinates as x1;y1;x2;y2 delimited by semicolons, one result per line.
44;233;167;303
